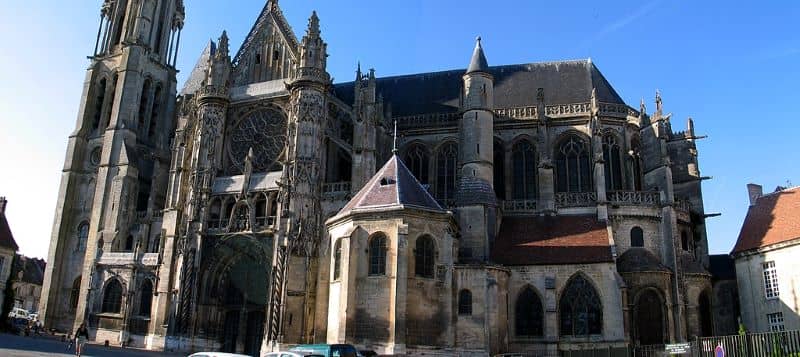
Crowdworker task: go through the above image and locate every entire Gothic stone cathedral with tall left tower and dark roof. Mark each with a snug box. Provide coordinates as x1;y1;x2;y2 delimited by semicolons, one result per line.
41;0;714;356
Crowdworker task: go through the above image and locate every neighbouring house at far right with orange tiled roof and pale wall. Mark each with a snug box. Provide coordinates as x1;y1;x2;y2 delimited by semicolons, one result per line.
731;184;800;332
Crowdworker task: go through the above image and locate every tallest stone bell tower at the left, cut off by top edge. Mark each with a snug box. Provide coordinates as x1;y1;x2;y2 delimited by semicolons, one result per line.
41;0;184;336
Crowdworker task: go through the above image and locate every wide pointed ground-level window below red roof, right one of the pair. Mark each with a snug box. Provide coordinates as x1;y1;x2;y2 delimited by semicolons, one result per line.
559;275;603;336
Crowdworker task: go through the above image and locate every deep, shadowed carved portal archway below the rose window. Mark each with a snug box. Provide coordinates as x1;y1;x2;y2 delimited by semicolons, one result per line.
197;235;273;356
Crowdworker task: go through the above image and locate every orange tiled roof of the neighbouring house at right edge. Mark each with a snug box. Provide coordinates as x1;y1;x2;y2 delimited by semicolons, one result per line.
732;187;800;254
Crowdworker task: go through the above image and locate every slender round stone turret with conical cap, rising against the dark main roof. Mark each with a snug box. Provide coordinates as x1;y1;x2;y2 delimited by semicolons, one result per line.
456;37;497;261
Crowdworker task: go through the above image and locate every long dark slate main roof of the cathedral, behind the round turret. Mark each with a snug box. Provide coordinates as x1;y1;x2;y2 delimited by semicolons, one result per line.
333;60;625;117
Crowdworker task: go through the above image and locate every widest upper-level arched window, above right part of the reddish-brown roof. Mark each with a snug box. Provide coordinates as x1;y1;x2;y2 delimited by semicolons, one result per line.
555;135;592;192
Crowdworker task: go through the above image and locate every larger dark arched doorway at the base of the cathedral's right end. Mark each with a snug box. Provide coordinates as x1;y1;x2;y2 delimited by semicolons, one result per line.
633;289;664;346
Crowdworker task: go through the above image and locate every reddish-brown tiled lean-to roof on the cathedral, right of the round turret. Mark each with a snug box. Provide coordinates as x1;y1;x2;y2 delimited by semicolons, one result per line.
492;216;614;265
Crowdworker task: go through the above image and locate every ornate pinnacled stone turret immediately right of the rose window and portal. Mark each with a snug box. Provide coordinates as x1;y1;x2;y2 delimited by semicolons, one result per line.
265;12;331;344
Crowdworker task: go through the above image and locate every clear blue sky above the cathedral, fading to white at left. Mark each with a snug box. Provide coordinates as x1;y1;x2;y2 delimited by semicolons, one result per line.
0;0;800;257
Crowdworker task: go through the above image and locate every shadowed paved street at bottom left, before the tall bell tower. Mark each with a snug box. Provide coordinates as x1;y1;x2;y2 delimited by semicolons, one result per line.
0;334;179;357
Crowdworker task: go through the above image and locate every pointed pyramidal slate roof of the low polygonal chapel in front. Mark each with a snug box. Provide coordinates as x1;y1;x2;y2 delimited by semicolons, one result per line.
339;155;444;215
